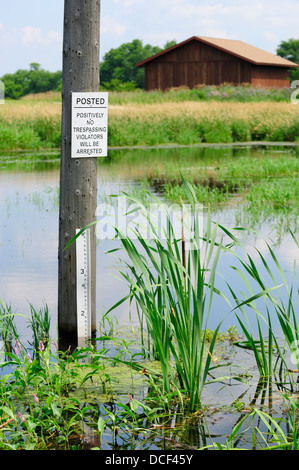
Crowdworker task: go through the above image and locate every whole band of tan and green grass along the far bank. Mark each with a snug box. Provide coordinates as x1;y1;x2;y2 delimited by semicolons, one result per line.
0;88;299;149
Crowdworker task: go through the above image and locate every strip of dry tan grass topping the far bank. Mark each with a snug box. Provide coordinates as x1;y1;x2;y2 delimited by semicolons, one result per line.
0;92;299;123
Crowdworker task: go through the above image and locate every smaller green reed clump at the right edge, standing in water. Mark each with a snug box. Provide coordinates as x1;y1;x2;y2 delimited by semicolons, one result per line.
227;225;299;379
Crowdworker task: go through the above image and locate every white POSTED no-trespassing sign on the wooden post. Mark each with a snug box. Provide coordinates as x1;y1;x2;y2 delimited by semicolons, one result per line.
72;92;108;158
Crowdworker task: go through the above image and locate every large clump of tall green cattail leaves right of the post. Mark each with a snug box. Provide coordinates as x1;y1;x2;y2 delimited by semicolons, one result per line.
104;181;280;410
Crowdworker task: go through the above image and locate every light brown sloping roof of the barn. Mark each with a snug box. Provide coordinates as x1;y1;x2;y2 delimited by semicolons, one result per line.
136;36;298;67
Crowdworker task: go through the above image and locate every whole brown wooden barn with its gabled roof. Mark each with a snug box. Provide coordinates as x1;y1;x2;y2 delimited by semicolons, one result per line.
136;36;298;91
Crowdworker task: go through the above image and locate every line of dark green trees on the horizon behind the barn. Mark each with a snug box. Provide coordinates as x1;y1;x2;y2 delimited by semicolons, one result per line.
1;39;299;99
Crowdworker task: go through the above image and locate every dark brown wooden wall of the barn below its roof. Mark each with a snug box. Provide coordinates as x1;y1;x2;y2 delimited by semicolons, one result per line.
145;40;289;91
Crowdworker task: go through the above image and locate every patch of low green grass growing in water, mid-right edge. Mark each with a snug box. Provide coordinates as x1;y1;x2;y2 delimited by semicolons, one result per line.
147;152;299;234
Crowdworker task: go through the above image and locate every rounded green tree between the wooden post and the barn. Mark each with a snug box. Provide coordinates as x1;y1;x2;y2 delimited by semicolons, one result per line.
100;39;175;88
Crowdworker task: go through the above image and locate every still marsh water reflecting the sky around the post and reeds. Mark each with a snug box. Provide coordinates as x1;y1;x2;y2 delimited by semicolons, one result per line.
0;146;298;447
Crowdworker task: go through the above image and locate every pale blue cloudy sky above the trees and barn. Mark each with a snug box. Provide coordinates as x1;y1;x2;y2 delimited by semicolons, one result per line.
0;0;299;76
